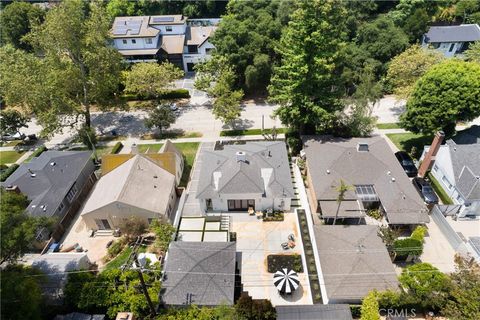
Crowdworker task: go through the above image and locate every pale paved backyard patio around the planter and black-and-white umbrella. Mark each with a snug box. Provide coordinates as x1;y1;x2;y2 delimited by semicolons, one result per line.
230;213;312;306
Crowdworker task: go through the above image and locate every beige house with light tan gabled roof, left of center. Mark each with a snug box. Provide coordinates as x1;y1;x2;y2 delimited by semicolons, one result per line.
81;154;177;230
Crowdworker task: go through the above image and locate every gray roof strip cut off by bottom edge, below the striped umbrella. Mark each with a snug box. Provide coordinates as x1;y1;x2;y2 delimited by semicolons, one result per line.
275;304;353;320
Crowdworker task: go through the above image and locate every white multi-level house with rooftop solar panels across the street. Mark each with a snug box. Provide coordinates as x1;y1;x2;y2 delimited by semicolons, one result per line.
112;15;219;72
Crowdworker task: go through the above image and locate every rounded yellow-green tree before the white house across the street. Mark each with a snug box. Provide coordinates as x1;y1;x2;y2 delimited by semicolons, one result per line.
125;62;183;99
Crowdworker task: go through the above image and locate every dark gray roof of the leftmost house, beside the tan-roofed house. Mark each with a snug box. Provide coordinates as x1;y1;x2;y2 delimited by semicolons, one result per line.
2;151;92;216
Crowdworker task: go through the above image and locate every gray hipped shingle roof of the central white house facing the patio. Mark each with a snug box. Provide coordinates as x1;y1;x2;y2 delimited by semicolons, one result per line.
197;141;294;199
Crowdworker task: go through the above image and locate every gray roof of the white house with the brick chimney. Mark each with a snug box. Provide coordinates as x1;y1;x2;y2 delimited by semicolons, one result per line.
446;140;480;200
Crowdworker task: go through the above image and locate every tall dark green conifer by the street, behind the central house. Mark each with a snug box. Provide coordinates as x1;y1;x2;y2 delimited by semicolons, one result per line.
268;0;346;134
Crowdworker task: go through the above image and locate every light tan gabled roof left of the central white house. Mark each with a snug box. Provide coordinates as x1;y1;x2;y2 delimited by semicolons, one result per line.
82;155;175;215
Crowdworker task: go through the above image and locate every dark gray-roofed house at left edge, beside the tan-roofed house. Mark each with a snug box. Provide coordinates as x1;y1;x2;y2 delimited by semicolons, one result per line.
2;151;97;242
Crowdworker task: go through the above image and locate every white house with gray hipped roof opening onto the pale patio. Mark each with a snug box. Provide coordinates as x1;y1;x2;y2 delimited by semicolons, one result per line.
196;141;294;212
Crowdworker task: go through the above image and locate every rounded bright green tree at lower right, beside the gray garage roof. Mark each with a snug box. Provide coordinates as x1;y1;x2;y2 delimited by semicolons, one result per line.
399;263;452;310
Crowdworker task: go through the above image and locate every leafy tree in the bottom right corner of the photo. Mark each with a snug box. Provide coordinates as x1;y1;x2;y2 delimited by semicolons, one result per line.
442;255;480;320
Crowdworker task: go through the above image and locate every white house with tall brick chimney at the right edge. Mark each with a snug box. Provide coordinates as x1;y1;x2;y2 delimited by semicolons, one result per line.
419;126;480;218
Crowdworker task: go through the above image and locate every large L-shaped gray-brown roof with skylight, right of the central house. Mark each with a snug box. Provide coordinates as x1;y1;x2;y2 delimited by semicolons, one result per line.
303;136;429;224
